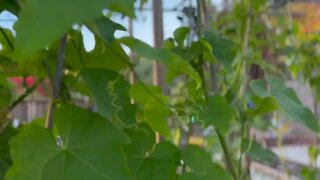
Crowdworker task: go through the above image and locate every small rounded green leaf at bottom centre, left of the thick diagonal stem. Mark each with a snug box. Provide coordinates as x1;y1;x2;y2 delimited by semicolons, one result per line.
181;145;212;175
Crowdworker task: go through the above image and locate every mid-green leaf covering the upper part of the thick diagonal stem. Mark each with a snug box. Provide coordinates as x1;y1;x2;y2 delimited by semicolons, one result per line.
199;96;234;134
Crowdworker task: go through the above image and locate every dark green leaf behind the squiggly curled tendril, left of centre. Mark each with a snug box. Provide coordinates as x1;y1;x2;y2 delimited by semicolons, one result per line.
81;68;136;126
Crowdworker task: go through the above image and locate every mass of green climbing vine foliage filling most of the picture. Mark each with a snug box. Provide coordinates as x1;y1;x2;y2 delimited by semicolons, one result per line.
0;0;320;180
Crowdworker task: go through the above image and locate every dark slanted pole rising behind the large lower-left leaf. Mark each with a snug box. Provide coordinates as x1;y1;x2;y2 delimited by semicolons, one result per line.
45;35;67;129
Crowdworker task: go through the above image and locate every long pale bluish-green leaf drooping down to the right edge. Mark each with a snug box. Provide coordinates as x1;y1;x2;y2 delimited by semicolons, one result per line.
250;75;319;133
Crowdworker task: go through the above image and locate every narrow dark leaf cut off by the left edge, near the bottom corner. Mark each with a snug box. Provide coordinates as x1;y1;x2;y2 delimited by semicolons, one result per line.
0;126;17;179
